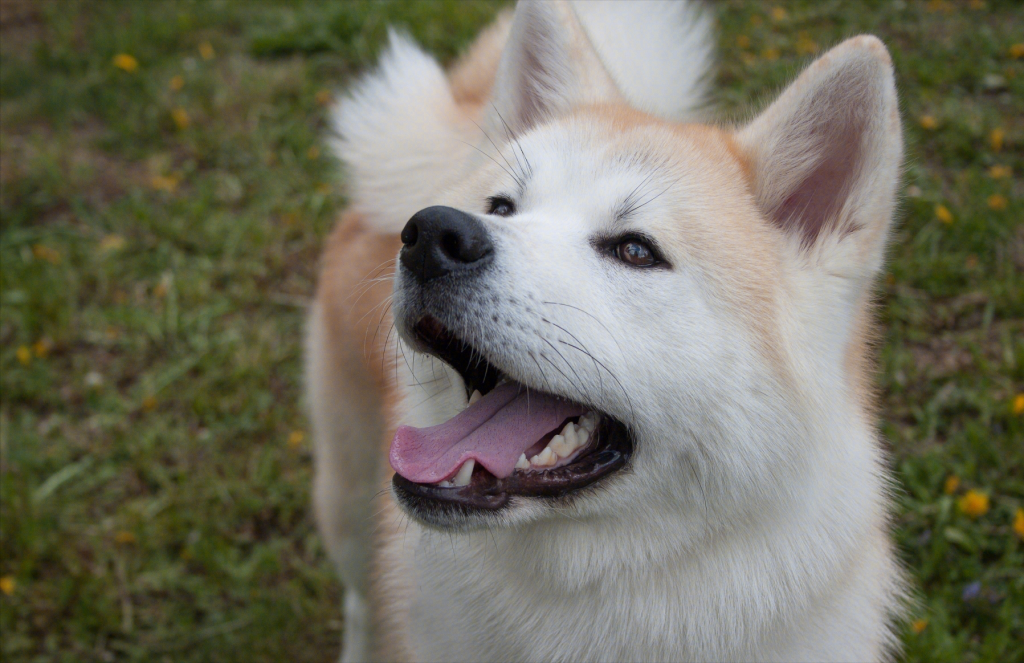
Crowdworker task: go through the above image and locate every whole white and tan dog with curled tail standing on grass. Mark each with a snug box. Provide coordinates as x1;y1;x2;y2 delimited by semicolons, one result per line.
305;0;906;661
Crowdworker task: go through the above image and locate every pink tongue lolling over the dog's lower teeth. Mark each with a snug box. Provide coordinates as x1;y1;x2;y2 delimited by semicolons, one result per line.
389;382;586;484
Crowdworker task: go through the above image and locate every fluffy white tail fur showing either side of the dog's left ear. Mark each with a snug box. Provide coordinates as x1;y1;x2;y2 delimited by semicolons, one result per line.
332;0;714;233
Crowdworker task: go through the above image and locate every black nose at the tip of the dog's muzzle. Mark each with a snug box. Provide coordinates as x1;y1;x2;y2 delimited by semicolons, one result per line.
399;205;494;283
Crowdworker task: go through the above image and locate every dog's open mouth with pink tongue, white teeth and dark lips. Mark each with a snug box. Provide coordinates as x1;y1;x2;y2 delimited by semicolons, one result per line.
390;317;633;524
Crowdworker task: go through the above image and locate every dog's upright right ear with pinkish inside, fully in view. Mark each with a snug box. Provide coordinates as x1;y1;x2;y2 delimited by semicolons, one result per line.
736;36;903;284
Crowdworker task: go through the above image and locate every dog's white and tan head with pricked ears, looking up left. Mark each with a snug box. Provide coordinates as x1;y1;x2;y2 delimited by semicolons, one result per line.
391;2;901;541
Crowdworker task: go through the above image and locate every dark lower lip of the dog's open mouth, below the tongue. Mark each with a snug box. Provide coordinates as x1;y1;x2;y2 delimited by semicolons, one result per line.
391;415;633;527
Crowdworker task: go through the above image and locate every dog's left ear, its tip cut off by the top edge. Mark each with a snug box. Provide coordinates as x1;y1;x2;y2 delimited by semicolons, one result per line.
488;0;622;132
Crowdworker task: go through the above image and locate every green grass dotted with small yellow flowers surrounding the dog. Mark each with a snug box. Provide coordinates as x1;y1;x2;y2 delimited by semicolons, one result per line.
0;0;1024;662
